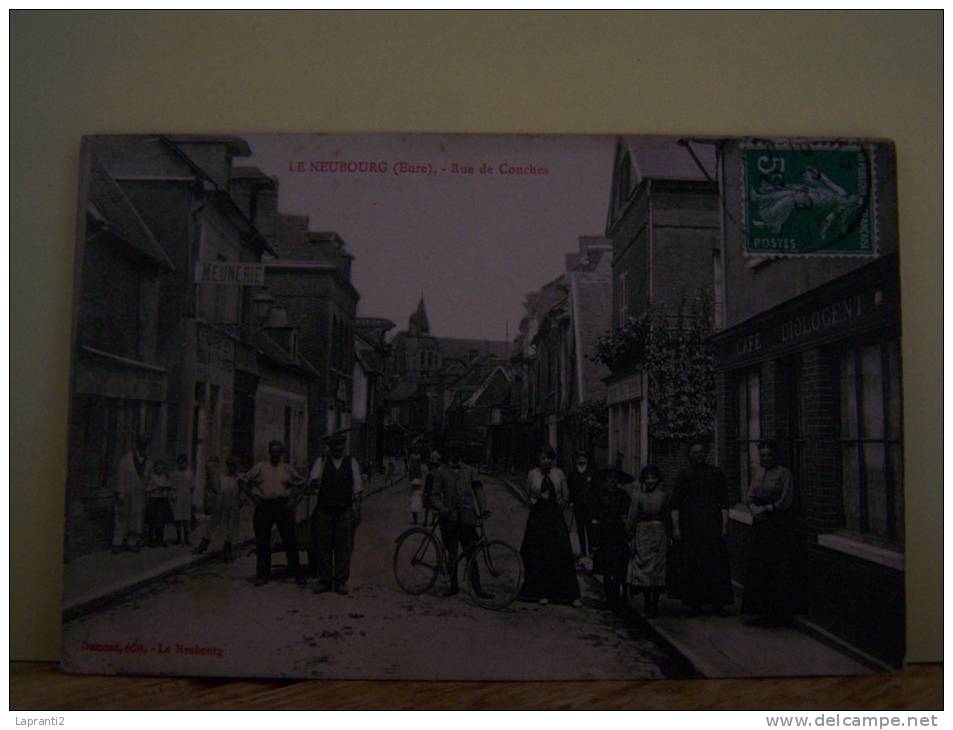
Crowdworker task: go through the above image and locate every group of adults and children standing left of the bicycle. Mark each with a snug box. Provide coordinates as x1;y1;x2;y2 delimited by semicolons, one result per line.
113;434;364;595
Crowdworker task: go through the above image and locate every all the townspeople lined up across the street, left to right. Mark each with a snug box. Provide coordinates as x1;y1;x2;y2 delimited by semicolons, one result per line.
113;426;798;625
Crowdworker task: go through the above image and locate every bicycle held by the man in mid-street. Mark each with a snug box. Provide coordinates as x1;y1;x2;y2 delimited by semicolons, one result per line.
394;512;523;611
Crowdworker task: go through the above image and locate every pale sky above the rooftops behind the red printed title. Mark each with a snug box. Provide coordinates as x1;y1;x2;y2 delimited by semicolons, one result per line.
242;134;615;340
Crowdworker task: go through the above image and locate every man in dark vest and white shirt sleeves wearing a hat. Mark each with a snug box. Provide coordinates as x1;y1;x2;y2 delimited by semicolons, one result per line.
310;434;364;596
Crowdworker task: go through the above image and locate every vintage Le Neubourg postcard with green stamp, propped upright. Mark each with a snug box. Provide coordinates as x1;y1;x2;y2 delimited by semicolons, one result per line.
63;134;904;680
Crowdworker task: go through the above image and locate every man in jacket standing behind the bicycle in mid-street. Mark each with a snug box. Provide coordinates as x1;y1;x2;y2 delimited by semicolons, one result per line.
430;448;492;599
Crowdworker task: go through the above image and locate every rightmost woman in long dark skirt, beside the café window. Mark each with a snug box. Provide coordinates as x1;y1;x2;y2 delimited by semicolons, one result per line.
741;441;797;626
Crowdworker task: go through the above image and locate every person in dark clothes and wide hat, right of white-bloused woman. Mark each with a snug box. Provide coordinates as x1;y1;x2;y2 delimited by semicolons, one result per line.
592;467;635;611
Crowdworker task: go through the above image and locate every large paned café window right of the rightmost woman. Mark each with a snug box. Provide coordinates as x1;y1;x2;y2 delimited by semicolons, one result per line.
839;340;903;543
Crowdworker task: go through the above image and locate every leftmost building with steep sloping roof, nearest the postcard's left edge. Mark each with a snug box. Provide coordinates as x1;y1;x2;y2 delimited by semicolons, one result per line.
65;154;175;559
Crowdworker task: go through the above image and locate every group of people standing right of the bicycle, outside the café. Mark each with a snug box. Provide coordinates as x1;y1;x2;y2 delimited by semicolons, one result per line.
520;440;797;625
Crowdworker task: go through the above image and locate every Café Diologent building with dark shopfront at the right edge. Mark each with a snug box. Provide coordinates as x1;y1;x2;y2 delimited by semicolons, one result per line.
713;142;904;665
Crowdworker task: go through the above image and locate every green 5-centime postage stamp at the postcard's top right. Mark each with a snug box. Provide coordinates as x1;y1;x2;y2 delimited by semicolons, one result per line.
742;140;877;256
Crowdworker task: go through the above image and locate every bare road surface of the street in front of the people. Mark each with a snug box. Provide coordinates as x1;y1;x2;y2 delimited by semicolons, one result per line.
63;478;692;680
